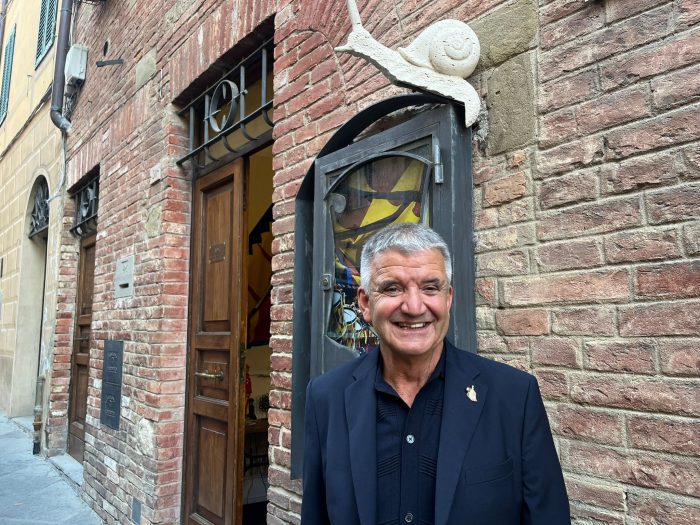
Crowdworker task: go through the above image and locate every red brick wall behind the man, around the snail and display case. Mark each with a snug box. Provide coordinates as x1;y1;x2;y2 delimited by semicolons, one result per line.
268;0;700;524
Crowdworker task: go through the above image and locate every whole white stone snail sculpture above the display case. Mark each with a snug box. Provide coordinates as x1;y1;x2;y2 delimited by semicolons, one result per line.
336;0;481;127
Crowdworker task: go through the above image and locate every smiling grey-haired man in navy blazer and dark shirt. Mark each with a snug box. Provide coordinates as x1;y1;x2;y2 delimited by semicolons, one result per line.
302;223;570;525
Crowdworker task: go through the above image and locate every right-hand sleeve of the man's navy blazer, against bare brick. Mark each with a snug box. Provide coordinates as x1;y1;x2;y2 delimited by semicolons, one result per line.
521;377;571;525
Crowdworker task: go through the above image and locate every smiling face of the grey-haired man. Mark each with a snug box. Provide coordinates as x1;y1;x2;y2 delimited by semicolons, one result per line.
358;250;452;359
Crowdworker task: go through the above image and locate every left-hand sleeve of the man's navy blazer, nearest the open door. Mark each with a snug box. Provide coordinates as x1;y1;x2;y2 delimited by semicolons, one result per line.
301;381;330;525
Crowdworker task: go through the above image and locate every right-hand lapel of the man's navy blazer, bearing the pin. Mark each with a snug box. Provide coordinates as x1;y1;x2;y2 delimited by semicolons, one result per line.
435;342;488;525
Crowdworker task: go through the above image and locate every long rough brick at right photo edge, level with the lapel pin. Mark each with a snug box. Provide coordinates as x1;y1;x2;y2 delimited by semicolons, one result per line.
571;375;700;416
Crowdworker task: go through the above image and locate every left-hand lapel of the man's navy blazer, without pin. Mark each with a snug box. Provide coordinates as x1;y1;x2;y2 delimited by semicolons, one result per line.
345;350;379;525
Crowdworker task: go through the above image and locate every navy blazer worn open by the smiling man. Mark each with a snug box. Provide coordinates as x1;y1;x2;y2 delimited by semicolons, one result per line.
301;342;571;525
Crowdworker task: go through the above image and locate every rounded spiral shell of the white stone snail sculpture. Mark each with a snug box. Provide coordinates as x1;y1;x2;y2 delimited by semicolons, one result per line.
398;20;481;78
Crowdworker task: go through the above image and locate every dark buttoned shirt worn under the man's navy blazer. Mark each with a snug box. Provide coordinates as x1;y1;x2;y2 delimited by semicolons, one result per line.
374;350;445;525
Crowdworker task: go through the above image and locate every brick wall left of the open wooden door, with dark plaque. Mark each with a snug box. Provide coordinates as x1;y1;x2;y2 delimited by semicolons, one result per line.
48;0;273;524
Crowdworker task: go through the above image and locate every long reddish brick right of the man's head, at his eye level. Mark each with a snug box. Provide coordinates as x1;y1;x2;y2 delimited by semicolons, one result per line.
503;270;629;306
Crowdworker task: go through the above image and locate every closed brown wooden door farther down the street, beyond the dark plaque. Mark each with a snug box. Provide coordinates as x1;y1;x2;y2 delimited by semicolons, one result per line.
68;235;95;463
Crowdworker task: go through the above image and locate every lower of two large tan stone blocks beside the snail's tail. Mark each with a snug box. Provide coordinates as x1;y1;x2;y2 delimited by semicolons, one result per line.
486;53;536;155
